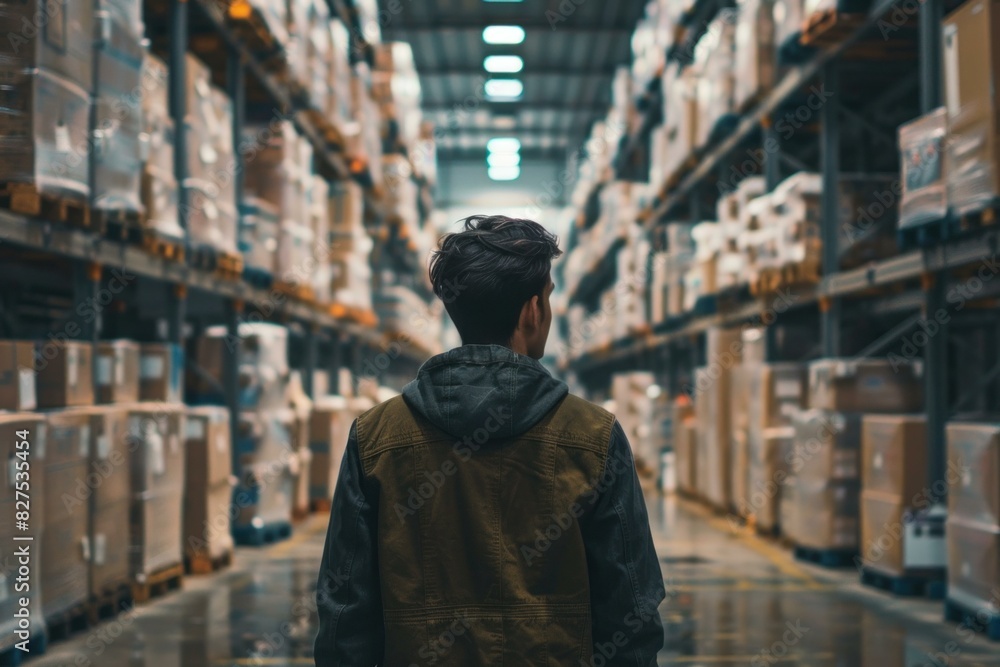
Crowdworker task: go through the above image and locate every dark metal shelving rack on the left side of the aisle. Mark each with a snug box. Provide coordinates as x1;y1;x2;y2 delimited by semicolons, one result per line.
0;0;427;433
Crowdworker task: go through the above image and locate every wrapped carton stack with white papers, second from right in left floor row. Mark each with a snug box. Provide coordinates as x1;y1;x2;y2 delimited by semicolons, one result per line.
128;403;187;583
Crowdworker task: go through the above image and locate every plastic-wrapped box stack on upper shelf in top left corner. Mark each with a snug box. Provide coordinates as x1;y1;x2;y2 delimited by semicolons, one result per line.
0;0;94;202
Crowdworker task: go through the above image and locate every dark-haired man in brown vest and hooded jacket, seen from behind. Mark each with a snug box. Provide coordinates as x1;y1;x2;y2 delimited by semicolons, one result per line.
315;216;664;667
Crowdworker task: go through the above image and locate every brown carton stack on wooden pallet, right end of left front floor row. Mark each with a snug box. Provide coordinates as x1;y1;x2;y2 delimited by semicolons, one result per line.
183;406;233;560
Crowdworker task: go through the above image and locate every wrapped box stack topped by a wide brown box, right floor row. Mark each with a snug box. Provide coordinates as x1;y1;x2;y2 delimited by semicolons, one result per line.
780;359;923;552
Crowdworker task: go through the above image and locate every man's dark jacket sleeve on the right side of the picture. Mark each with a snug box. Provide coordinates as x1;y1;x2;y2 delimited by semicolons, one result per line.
580;421;666;667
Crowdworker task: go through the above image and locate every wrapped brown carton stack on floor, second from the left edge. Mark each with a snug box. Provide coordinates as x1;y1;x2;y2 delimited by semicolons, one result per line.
41;410;90;618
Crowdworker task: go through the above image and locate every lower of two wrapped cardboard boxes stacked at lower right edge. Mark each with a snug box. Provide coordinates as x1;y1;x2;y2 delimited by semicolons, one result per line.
945;515;1000;613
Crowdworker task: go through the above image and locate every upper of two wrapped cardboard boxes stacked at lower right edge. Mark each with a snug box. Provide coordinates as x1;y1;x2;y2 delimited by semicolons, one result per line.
946;422;1000;526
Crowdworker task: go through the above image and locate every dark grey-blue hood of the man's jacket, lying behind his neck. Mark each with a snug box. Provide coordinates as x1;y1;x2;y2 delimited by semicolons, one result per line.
403;345;569;439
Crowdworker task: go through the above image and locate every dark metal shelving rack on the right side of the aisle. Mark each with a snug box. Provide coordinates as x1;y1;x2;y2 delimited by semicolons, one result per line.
562;0;1000;496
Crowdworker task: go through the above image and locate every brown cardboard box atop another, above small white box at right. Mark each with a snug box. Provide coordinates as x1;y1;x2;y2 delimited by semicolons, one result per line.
861;415;928;503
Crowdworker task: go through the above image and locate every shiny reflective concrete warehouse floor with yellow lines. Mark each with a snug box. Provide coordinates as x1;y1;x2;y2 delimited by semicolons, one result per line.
19;497;1000;667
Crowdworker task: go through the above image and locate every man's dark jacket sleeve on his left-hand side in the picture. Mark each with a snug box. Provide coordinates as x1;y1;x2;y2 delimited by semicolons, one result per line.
315;422;385;667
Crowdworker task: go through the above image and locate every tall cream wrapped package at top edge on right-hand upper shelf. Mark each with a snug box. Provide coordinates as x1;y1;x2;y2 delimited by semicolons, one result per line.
733;0;777;111
